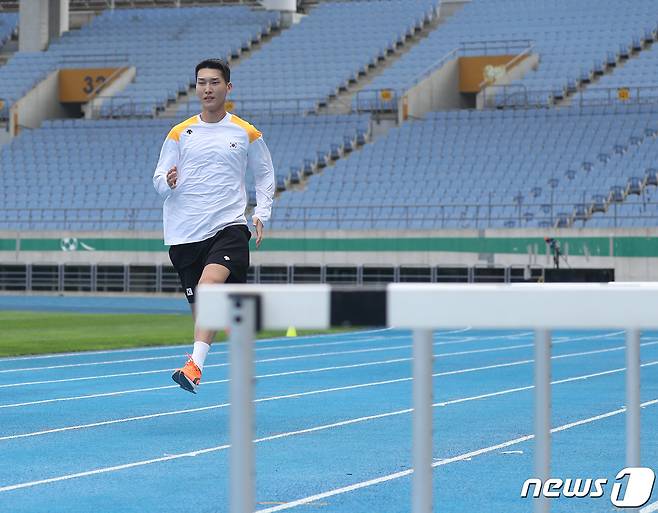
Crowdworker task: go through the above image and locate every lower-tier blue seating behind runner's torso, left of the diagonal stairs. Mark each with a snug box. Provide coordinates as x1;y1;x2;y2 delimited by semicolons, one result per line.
0;116;368;230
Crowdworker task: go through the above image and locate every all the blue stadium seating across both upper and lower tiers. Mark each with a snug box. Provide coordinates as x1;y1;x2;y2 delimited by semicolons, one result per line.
0;0;658;234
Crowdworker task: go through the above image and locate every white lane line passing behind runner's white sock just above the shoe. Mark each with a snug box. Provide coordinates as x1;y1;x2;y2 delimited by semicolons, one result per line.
0;332;512;374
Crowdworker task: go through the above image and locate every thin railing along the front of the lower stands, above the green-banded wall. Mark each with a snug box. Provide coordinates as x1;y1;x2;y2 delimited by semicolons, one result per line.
0;199;658;231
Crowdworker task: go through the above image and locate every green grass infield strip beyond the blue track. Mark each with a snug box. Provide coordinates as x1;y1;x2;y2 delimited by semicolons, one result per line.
0;311;347;357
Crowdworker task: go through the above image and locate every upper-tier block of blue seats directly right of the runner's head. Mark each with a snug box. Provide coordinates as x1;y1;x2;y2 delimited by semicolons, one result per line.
183;0;438;112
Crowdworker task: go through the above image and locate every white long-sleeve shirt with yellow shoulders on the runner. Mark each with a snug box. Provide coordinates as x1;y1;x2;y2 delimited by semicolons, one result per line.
153;113;275;246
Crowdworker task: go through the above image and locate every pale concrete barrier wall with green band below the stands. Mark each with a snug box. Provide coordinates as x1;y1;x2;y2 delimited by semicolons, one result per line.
0;228;658;281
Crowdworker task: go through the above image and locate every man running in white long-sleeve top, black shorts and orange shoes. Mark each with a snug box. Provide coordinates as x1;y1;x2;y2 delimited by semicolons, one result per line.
153;59;274;393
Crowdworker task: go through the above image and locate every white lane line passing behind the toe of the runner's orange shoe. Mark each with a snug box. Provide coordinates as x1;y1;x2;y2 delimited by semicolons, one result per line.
0;342;644;409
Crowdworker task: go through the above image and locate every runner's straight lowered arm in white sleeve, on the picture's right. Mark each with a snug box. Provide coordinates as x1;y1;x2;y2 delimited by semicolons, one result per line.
247;137;275;247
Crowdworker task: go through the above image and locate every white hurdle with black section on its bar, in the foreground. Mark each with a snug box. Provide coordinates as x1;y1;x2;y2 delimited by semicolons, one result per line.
197;283;658;513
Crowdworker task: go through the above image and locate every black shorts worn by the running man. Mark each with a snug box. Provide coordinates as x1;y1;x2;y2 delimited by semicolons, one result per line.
169;224;251;303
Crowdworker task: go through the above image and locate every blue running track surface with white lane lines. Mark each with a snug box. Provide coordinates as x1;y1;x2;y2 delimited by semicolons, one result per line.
0;329;658;513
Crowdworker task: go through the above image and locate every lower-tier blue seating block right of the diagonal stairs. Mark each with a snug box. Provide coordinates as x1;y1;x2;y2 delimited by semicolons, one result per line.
272;107;658;229
